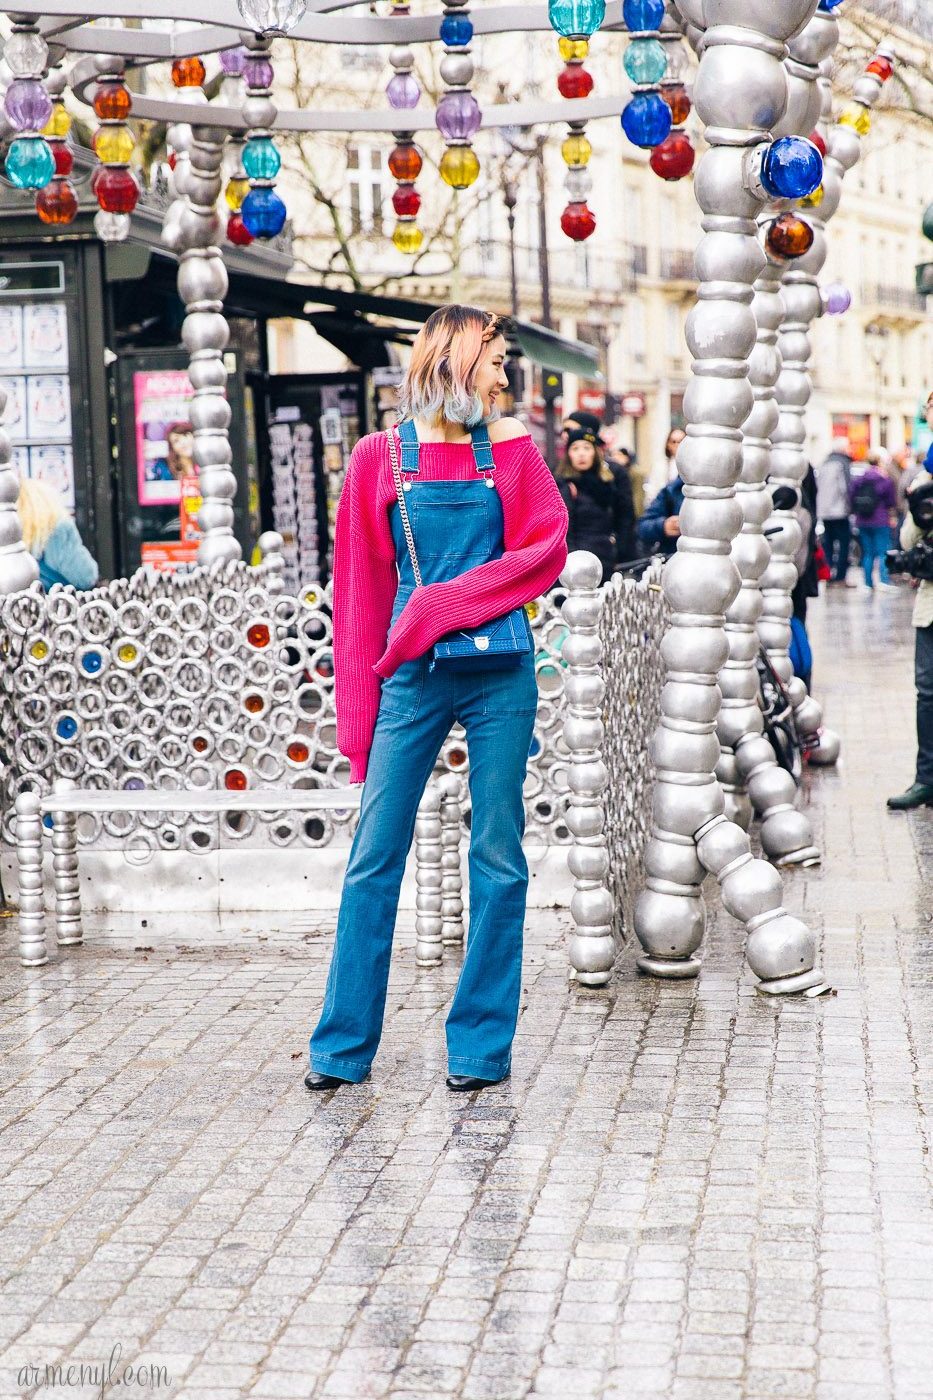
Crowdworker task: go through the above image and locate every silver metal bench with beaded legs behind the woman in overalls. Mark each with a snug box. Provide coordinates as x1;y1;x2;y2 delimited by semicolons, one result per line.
14;774;464;967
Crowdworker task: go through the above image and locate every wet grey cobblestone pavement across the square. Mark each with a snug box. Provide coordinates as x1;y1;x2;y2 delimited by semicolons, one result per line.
0;592;933;1400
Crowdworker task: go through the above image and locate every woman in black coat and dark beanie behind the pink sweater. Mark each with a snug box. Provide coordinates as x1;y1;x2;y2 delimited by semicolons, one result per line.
558;428;635;582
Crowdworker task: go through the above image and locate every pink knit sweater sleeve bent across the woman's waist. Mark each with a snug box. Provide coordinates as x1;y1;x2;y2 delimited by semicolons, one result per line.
375;437;567;676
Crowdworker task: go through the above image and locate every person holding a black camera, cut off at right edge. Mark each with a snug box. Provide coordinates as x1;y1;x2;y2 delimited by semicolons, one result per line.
888;393;933;812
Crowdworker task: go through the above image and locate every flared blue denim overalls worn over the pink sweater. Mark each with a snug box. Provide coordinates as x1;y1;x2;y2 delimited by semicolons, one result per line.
311;421;538;1082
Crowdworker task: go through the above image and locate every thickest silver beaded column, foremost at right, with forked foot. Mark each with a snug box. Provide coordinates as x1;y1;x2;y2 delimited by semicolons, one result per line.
635;0;825;994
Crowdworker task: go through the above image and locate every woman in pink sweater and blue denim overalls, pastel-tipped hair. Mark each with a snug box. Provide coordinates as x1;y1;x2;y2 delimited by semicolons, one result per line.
304;307;567;1091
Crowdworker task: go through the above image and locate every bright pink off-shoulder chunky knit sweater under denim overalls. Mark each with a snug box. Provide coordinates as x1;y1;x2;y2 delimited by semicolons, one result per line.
333;433;567;783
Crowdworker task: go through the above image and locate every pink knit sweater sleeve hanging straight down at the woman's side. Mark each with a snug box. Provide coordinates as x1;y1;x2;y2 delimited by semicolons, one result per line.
332;437;398;783
